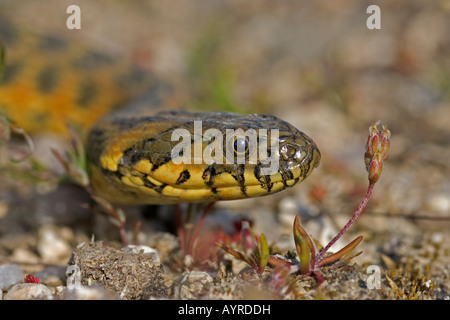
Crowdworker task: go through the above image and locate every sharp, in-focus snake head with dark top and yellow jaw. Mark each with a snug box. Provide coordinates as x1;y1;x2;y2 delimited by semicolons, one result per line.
88;111;320;204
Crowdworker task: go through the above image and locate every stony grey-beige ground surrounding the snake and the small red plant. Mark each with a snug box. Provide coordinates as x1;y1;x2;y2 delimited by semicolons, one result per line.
0;0;450;300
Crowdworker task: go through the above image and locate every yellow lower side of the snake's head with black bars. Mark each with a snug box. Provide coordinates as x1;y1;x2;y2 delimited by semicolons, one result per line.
91;155;312;205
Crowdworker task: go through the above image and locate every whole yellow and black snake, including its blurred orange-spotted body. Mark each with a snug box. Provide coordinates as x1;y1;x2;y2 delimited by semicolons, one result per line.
0;19;321;205
